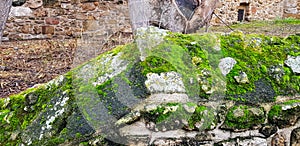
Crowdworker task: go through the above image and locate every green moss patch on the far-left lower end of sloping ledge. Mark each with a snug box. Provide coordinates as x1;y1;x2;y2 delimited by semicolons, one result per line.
0;72;71;145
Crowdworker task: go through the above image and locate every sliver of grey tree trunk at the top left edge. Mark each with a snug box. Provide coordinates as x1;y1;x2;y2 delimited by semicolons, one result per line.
0;0;12;43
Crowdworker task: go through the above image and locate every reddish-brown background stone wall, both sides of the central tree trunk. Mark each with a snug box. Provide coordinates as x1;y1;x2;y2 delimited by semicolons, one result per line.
3;0;300;41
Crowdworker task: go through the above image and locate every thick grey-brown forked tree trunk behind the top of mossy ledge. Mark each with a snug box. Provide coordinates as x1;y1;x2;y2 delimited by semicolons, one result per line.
129;0;218;33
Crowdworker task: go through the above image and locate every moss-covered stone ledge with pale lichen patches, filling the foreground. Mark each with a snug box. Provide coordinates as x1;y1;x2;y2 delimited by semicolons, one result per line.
0;28;300;146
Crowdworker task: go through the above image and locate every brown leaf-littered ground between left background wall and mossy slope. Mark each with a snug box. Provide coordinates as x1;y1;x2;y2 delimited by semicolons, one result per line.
0;30;132;98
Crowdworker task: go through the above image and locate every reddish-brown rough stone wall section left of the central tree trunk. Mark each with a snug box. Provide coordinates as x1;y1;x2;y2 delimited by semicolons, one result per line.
3;0;130;40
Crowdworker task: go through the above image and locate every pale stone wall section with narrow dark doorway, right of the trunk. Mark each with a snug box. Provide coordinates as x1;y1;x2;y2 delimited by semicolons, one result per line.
212;0;300;25
